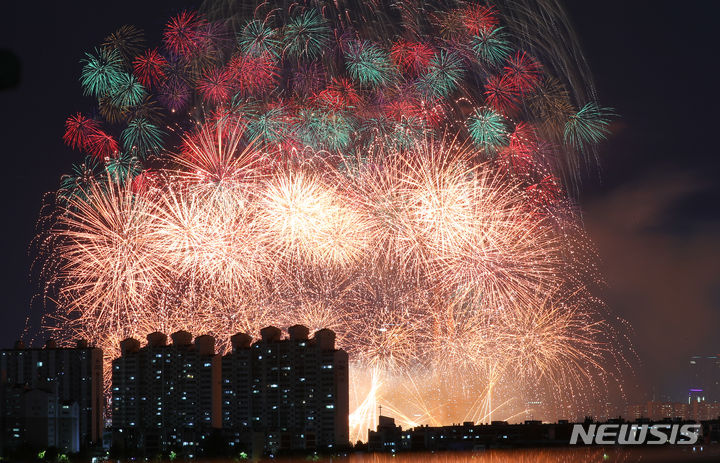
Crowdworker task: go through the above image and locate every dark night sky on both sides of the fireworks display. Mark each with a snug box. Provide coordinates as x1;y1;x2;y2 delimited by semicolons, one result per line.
0;0;720;404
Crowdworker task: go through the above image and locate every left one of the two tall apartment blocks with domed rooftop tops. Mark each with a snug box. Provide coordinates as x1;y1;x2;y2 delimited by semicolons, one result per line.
112;331;221;456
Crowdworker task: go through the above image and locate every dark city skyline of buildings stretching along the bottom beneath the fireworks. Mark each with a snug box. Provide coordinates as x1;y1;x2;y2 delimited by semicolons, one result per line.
0;325;720;458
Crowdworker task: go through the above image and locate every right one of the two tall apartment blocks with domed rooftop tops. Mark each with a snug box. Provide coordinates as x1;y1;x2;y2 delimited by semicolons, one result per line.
222;325;349;453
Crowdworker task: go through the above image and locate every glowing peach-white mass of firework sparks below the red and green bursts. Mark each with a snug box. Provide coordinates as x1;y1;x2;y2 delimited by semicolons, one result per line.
40;123;624;438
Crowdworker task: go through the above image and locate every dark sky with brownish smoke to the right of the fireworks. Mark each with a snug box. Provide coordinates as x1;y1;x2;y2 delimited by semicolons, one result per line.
567;1;720;401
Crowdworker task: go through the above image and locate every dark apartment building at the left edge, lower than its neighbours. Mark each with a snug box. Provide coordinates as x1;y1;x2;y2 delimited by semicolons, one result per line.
0;341;104;453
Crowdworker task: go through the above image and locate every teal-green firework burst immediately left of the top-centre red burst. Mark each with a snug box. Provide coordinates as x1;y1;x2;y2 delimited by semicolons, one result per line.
345;40;395;87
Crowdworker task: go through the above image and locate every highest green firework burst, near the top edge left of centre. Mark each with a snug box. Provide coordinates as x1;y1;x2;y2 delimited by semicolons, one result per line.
283;10;330;59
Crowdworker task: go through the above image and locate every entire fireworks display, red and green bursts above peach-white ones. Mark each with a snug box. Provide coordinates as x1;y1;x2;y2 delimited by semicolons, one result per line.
38;2;622;439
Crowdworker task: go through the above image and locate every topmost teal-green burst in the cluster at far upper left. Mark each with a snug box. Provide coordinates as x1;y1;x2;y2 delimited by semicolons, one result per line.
80;48;125;98
